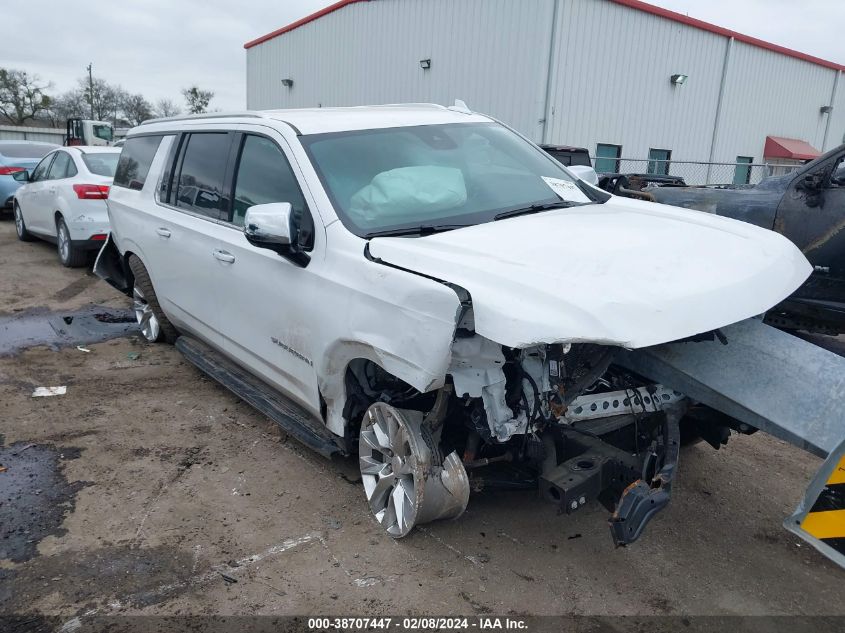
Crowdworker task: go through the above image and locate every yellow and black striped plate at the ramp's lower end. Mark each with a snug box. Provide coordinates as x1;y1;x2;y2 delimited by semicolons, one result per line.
784;442;845;567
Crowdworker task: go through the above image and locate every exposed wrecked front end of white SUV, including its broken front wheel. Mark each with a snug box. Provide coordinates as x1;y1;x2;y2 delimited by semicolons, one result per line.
344;330;732;545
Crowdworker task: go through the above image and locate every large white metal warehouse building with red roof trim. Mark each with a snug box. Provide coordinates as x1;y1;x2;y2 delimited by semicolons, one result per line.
245;0;845;183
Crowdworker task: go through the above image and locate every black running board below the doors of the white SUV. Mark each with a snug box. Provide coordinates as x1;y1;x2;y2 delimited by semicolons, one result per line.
176;336;346;458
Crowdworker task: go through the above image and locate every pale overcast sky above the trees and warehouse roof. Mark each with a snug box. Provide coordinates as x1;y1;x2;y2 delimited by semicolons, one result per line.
0;0;845;110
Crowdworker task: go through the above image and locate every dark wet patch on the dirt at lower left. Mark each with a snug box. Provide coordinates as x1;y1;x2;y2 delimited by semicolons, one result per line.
0;442;87;563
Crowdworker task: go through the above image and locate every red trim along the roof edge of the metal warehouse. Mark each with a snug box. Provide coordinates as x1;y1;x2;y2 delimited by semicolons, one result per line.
244;0;845;71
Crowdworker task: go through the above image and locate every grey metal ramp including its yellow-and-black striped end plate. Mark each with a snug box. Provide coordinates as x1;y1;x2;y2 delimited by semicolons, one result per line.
616;319;845;567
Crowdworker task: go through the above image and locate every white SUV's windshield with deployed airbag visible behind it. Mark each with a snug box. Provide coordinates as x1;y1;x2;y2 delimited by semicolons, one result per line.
300;123;597;237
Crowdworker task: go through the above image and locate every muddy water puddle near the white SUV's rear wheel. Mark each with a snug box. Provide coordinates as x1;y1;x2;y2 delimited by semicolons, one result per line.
0;306;139;356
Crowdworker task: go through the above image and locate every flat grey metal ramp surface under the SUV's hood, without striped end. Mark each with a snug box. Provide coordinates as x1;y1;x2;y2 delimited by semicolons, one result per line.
614;319;845;457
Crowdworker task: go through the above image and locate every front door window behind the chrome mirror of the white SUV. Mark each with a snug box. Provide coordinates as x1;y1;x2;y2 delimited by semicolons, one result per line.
231;135;314;248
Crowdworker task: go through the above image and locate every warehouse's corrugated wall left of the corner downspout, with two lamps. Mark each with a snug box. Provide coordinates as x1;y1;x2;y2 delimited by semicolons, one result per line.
247;0;553;136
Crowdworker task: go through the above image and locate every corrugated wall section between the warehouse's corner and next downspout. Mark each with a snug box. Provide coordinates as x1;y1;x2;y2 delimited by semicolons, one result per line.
548;0;726;160
